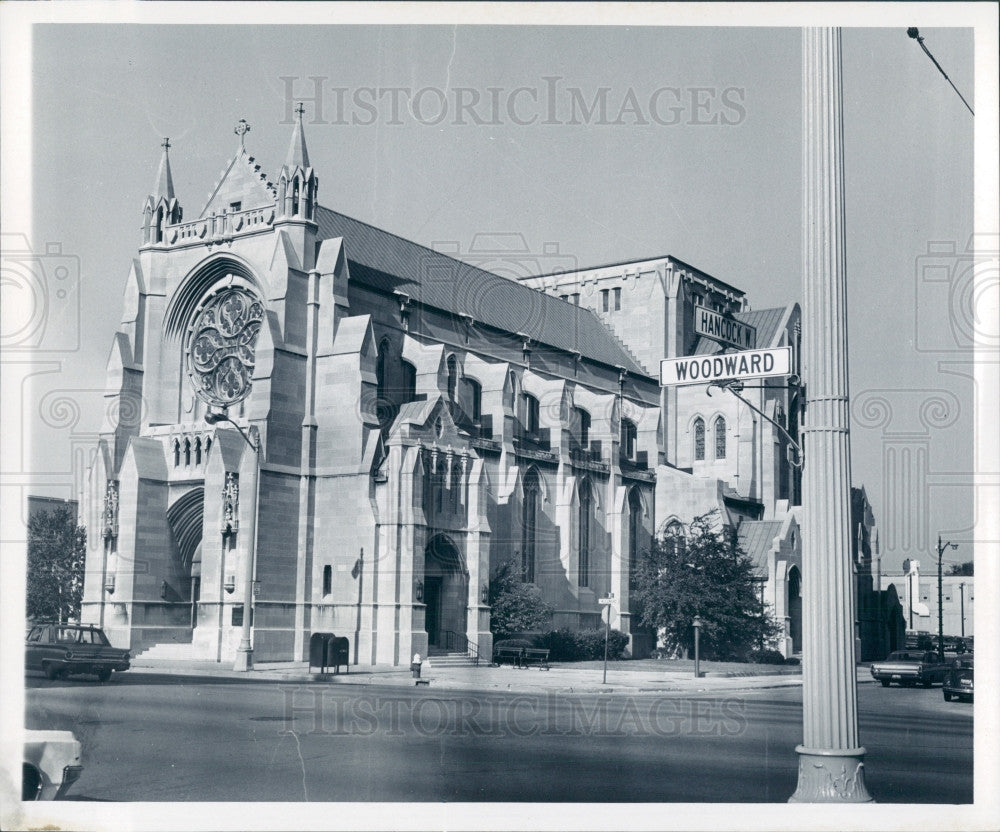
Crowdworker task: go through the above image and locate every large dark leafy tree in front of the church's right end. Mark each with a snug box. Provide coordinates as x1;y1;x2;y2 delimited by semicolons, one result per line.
631;514;780;660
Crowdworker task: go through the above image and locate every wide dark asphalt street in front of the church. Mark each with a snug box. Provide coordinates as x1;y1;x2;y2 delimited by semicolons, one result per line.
26;671;973;803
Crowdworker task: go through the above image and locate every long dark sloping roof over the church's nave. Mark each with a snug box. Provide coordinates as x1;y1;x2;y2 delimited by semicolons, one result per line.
315;205;649;377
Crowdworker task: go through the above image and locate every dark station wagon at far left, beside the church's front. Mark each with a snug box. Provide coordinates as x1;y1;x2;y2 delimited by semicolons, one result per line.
24;624;131;682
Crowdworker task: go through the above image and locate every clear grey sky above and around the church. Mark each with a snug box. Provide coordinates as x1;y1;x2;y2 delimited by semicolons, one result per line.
4;14;975;572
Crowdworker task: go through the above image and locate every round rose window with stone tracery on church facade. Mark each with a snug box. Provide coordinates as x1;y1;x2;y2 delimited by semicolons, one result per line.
187;287;264;407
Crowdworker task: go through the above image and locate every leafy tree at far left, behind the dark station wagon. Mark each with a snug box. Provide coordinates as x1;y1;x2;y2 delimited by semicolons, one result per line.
27;507;87;622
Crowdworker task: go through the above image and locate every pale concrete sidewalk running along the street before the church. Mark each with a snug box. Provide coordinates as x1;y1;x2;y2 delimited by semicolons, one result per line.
132;656;828;693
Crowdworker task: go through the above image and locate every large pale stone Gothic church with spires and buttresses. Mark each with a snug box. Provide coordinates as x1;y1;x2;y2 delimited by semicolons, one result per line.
80;108;860;665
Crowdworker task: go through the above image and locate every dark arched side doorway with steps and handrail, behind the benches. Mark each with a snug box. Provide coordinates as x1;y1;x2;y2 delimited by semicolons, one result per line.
424;534;469;647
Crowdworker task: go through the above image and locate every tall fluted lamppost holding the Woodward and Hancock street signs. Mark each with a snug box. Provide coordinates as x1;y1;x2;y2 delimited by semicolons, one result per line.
790;28;872;803
